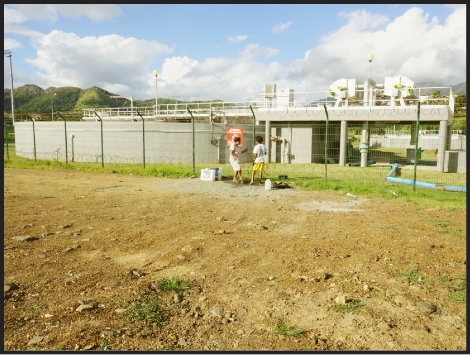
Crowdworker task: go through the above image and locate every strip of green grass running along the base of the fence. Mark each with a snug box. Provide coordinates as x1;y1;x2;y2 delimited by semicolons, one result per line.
3;146;466;210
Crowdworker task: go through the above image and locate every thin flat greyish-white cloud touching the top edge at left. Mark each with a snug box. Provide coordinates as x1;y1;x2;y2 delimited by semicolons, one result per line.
9;4;122;22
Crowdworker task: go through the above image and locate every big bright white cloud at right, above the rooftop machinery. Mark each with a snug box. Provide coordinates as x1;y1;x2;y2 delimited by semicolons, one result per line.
288;7;466;91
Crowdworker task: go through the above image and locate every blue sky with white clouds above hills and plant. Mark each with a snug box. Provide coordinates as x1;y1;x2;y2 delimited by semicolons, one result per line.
3;4;467;102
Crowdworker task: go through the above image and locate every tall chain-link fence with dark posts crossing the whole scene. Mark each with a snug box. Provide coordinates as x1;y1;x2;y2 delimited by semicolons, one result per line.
4;115;466;192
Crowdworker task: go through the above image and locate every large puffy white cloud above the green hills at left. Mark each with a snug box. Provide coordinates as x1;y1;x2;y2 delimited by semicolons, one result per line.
26;31;172;97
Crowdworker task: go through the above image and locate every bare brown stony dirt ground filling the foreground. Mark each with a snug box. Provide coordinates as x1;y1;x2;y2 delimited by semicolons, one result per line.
3;169;466;351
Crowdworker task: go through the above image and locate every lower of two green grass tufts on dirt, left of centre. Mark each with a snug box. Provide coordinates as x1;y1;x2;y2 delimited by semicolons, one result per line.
124;294;165;325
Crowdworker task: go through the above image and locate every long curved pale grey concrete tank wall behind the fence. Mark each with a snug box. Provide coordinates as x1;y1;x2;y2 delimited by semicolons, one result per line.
15;121;258;164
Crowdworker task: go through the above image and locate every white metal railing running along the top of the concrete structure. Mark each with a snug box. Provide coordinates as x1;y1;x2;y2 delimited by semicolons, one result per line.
82;87;454;120
